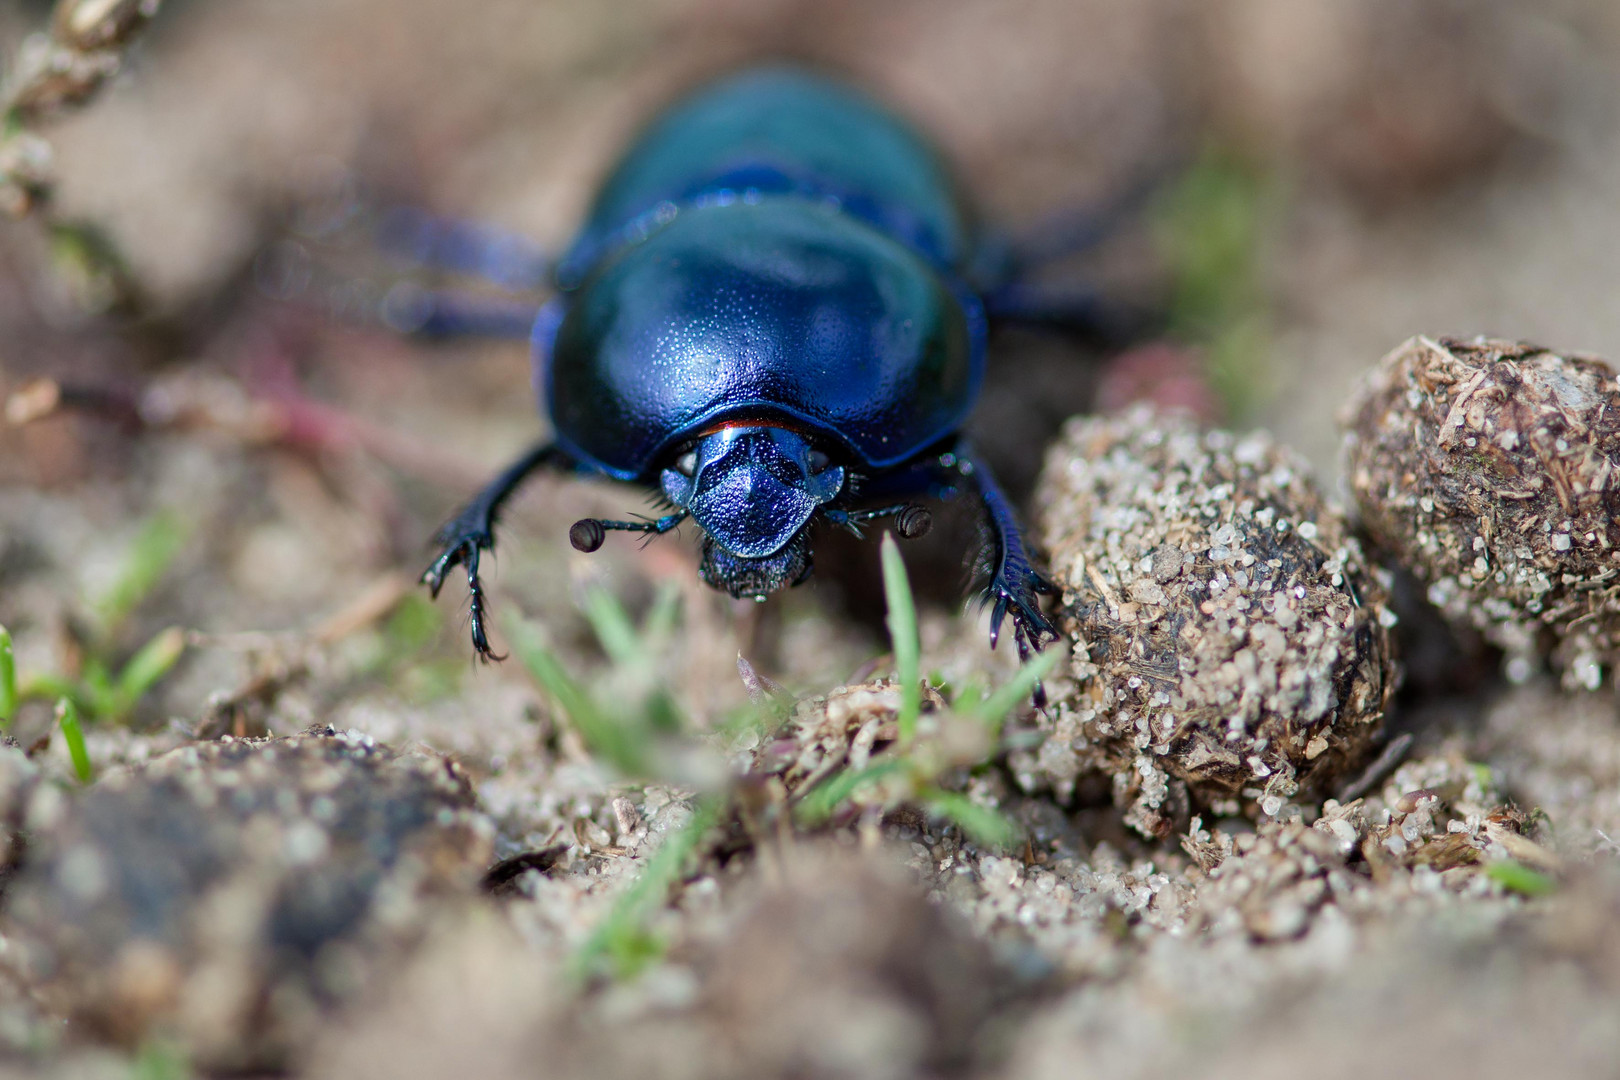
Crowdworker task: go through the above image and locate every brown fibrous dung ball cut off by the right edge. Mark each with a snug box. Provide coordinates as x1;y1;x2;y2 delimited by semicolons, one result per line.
1345;337;1620;688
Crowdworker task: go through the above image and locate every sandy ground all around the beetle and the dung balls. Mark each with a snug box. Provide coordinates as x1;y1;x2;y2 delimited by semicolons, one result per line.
0;0;1620;1078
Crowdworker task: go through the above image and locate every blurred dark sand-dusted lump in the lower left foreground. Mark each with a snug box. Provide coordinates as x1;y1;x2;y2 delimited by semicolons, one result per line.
5;729;491;1069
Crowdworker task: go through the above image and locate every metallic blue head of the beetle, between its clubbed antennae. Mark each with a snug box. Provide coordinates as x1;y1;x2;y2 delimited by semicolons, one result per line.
661;424;844;597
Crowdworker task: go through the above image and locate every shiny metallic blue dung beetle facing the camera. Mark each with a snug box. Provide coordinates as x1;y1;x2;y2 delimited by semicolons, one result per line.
413;68;1127;676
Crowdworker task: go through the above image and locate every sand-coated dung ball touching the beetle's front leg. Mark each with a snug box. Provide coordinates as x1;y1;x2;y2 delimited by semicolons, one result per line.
1036;408;1395;836
